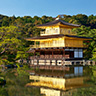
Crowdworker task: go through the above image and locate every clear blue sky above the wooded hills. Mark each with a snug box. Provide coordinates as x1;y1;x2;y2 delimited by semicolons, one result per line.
0;0;96;17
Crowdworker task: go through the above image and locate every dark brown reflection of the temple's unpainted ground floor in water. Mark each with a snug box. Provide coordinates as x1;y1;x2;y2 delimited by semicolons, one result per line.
30;66;83;78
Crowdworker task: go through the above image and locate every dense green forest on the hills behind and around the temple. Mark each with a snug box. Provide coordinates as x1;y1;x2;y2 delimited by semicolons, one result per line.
0;14;96;65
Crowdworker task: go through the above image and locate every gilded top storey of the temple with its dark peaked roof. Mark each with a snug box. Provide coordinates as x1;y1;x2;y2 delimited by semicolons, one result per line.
37;18;80;36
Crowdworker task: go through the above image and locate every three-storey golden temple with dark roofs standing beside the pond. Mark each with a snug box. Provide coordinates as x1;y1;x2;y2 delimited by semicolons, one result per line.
26;18;92;69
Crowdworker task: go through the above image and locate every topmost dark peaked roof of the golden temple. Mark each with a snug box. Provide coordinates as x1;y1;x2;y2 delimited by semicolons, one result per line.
37;19;80;27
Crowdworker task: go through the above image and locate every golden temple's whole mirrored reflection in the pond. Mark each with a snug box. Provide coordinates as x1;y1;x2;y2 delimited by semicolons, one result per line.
27;66;91;96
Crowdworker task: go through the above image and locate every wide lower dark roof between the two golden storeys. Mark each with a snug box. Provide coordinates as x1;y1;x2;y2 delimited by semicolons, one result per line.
26;34;92;40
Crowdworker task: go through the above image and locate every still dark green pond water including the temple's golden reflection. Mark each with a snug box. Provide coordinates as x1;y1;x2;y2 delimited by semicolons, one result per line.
0;66;96;96
